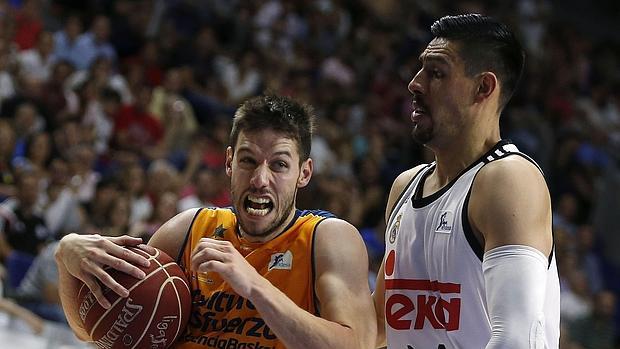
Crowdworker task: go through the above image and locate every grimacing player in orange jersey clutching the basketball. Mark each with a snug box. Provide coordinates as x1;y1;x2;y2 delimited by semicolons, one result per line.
56;96;376;349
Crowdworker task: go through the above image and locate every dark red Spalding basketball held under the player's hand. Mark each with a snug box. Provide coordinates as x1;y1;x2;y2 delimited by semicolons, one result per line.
77;247;191;349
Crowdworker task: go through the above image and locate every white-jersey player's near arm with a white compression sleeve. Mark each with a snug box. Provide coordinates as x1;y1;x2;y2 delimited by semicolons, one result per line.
469;156;553;349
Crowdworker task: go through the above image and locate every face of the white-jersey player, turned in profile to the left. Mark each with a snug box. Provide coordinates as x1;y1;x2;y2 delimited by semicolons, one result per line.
408;38;474;147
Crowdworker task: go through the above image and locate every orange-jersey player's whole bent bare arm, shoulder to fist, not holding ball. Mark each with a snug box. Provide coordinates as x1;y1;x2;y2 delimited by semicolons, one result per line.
192;219;376;349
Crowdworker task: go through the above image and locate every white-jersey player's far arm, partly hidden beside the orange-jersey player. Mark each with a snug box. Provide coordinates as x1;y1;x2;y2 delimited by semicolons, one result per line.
372;165;426;348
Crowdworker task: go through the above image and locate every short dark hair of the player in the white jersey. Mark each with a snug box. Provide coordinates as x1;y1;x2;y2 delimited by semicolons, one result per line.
431;14;525;110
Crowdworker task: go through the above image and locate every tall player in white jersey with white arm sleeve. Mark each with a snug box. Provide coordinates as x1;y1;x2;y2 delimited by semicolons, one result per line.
374;14;560;349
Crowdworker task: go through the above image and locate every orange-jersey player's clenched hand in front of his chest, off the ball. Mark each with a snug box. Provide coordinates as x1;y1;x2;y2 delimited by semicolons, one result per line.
192;238;260;299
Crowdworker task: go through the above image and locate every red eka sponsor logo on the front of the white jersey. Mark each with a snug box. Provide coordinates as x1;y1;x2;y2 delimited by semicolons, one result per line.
385;250;461;331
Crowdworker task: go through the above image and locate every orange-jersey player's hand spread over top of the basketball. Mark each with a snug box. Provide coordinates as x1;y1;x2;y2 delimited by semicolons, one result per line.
56;234;152;309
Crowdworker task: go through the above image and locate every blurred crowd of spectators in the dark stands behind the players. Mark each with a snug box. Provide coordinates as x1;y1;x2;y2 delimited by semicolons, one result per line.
0;0;620;349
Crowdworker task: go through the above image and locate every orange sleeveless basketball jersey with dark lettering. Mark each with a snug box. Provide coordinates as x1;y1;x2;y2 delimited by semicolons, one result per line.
175;208;333;349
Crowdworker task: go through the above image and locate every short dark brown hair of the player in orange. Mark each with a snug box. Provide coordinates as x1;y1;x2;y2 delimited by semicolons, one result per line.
230;95;316;161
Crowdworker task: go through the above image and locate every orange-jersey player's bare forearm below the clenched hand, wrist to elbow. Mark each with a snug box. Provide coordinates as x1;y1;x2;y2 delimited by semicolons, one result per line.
250;279;370;349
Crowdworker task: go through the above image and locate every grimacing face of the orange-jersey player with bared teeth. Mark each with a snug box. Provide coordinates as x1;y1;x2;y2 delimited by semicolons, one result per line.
226;130;312;240
